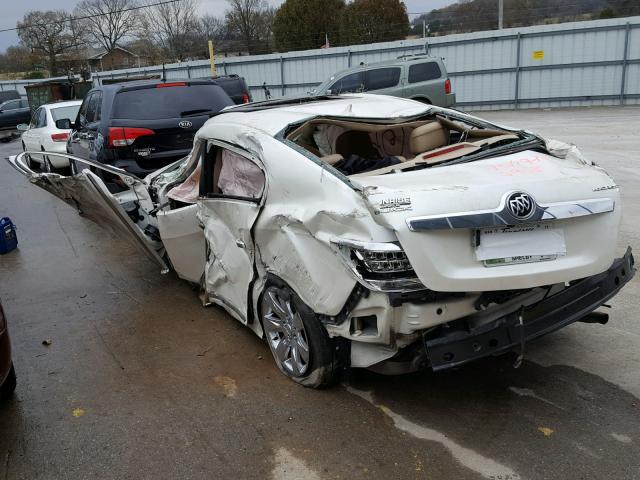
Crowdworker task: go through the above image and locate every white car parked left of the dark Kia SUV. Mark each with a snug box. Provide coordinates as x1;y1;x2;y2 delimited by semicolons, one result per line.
17;100;82;172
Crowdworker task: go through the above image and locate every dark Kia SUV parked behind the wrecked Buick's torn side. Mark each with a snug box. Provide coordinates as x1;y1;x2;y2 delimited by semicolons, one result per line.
56;80;234;177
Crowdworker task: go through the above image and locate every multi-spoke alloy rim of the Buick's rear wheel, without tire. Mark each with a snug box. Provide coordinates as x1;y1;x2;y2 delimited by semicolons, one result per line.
262;287;310;377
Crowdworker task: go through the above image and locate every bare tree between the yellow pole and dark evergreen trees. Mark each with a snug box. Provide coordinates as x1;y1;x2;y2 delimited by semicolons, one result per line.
225;0;273;53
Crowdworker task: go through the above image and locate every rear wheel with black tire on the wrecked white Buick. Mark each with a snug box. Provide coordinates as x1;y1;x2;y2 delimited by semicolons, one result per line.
260;279;344;388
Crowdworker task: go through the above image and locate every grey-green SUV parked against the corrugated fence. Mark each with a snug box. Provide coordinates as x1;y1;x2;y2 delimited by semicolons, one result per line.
311;55;456;107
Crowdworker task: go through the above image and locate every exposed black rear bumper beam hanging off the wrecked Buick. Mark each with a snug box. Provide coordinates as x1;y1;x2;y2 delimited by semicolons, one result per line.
424;247;635;371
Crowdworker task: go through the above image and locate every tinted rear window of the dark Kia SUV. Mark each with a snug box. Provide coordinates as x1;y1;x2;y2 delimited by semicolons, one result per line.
113;84;234;120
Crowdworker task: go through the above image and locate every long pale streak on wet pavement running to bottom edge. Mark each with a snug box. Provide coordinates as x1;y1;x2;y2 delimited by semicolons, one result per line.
346;387;521;480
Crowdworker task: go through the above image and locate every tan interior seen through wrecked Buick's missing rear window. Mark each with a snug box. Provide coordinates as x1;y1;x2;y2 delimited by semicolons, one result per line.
286;115;520;176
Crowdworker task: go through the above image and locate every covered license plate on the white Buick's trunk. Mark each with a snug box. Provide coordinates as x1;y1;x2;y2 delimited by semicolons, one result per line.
475;222;567;267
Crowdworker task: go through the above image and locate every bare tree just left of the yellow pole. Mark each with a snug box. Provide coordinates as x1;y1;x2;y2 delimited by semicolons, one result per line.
141;0;198;60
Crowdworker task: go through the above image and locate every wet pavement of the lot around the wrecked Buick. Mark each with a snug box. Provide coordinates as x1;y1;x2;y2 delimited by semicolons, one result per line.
0;108;640;480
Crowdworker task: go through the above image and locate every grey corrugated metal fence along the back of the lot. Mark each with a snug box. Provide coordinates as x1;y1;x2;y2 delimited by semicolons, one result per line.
0;16;640;110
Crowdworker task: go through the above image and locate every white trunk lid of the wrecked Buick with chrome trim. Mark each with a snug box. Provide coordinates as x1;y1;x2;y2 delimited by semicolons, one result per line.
358;151;620;291
